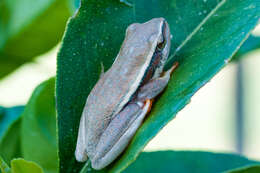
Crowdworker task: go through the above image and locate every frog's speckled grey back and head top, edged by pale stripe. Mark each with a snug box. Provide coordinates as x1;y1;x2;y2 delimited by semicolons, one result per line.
82;18;166;157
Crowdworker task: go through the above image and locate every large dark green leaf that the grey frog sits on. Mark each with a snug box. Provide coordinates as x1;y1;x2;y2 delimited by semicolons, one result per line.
56;0;260;172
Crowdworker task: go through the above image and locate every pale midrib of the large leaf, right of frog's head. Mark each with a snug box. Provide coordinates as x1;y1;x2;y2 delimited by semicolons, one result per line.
168;0;226;62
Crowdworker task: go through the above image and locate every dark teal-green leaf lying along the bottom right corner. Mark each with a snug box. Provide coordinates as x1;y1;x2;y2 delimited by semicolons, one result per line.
124;151;259;173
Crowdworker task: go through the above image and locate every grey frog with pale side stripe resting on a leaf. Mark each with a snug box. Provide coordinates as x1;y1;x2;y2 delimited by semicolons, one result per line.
75;17;178;170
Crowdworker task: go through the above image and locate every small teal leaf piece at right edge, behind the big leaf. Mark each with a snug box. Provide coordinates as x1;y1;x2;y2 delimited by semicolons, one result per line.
232;35;260;61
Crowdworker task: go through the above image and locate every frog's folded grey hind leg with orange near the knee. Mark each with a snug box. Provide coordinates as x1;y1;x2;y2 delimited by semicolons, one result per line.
90;100;151;170
